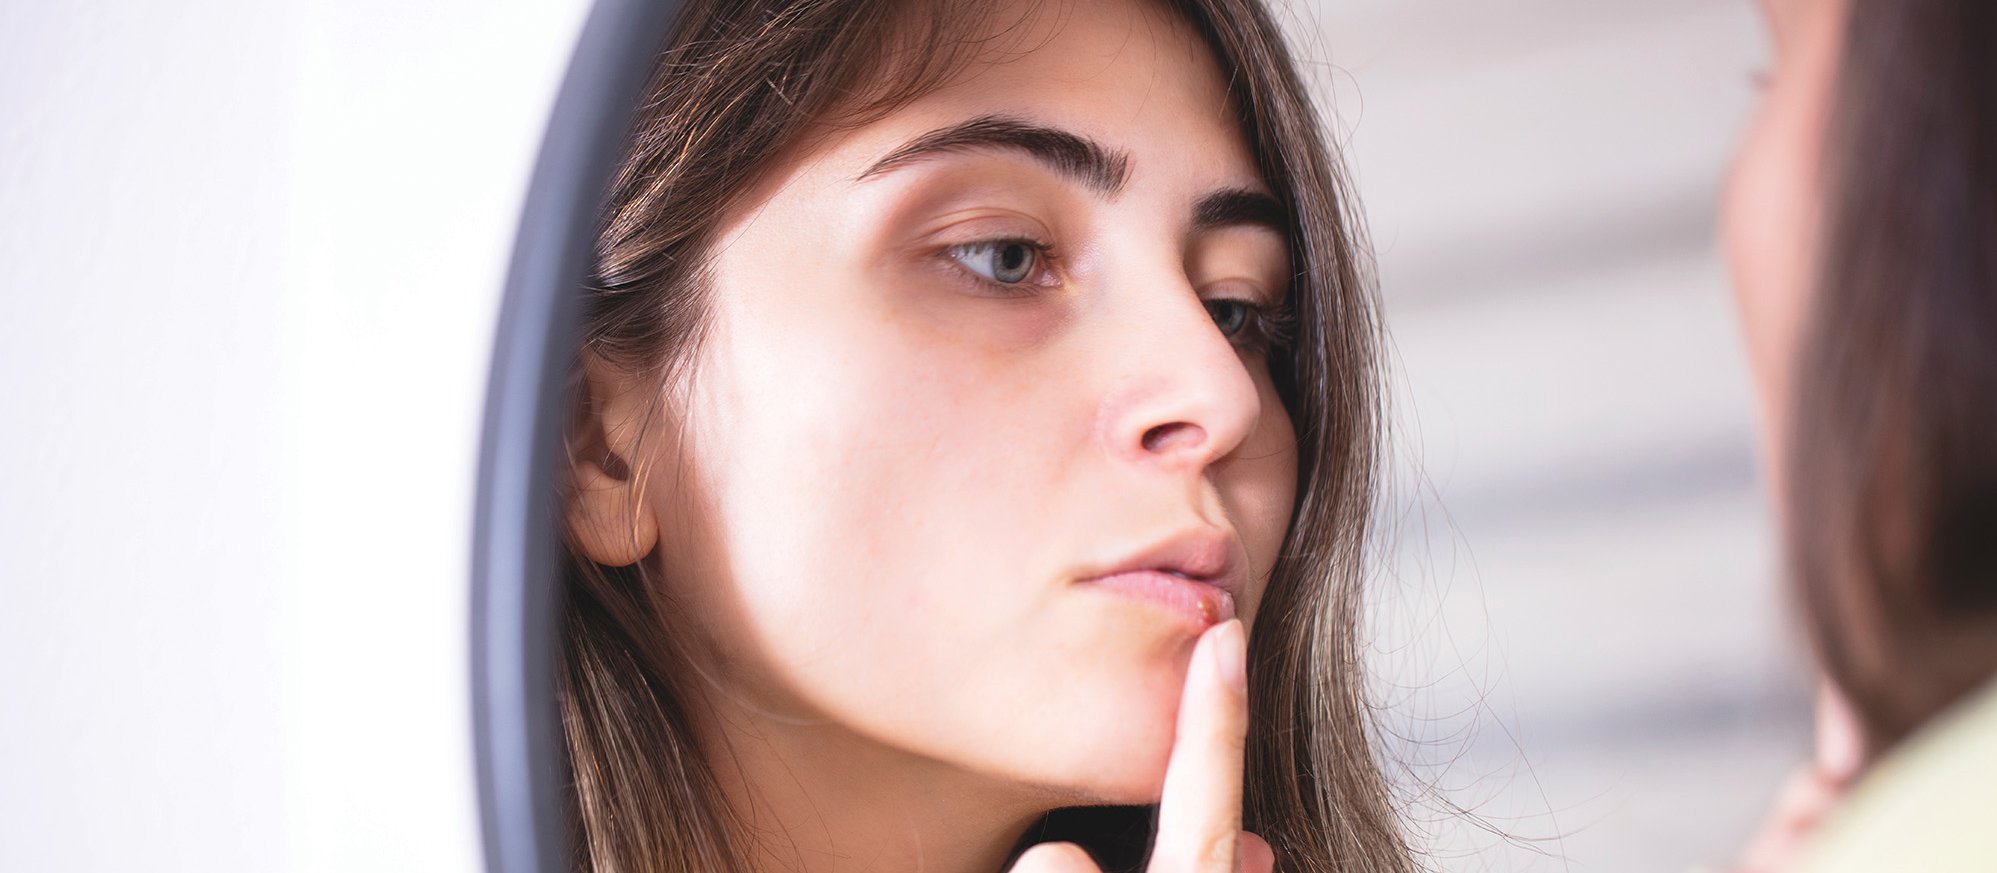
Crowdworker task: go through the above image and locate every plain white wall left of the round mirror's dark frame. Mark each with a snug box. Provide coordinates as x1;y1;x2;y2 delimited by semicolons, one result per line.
0;0;585;871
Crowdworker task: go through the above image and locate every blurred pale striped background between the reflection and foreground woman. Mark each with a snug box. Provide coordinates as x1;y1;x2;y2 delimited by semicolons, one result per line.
1288;0;1809;873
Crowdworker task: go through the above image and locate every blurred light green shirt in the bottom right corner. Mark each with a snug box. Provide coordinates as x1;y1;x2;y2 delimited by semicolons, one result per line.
1797;683;1997;873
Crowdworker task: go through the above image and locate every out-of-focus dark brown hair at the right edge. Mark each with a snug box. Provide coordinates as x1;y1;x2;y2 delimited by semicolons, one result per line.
1787;0;1997;753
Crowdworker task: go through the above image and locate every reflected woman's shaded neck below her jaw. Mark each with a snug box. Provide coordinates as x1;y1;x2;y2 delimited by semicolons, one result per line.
703;679;1060;873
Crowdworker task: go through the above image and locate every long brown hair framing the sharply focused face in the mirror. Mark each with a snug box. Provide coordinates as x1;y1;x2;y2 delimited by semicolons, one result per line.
561;0;1414;873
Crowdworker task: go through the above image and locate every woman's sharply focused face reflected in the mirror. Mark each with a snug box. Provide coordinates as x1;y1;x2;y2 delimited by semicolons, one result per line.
607;2;1296;801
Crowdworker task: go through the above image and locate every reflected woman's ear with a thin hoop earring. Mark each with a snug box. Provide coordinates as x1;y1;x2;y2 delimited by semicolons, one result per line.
563;350;659;567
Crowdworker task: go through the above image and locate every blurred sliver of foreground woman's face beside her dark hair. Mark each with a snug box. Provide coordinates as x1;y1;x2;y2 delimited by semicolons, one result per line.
1723;0;1845;479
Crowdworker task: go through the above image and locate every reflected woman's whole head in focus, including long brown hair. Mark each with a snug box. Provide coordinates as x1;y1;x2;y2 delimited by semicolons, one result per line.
565;0;1400;869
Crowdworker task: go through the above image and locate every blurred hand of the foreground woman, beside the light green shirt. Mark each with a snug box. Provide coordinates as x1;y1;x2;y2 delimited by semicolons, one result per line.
1733;683;1863;873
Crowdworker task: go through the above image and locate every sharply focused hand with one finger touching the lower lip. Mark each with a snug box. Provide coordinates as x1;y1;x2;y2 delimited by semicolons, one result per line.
1012;619;1276;873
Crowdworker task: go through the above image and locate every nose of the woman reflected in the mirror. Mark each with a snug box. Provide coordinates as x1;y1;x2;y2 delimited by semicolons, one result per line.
1102;280;1262;469
